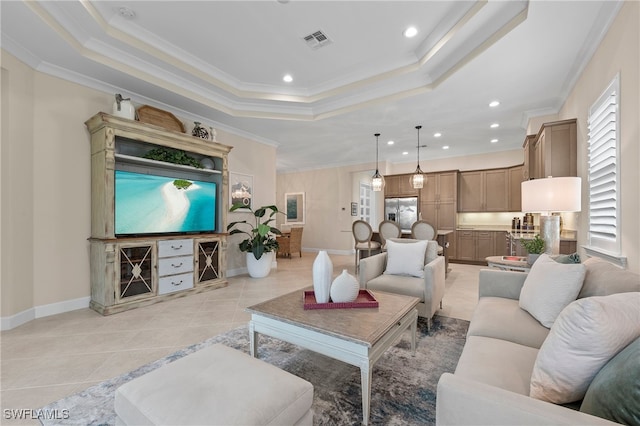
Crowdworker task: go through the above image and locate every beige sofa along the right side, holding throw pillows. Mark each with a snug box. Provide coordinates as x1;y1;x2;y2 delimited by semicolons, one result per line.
436;258;640;425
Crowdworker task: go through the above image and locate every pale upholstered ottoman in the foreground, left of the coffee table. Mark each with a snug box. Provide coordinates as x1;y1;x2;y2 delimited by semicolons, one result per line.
115;344;313;425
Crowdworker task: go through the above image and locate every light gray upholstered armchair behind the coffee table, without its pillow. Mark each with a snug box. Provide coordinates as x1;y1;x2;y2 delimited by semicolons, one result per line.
358;238;445;329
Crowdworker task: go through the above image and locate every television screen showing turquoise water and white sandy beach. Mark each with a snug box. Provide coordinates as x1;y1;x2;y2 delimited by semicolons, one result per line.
115;170;216;235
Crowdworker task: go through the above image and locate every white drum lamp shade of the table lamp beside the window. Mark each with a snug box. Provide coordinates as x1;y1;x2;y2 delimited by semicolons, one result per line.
521;177;582;214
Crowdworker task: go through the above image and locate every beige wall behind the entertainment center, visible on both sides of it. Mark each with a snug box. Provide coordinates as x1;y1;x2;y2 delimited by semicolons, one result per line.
0;50;276;327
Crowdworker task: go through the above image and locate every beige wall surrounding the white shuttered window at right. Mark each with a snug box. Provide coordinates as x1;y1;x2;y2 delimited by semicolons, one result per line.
558;1;640;272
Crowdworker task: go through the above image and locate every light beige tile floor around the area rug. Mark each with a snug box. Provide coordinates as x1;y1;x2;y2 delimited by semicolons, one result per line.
0;253;480;424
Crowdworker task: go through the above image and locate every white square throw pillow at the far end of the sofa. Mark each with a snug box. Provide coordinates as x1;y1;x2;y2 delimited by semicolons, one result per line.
518;254;586;328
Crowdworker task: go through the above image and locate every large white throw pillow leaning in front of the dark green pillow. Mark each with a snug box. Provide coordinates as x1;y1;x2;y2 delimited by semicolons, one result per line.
530;292;640;404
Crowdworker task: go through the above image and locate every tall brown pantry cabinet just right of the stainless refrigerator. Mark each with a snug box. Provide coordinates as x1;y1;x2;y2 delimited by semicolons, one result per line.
420;171;458;230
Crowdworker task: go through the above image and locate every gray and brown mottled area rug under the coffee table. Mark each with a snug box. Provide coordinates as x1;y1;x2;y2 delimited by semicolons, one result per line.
43;316;469;425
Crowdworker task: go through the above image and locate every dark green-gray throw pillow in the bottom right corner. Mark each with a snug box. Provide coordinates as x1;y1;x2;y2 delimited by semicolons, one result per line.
580;338;640;425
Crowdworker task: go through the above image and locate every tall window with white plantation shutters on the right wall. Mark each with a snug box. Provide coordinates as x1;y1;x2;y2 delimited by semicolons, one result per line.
587;75;620;257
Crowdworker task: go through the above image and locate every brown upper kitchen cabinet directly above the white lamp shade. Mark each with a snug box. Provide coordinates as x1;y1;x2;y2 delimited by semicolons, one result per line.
525;119;578;179
